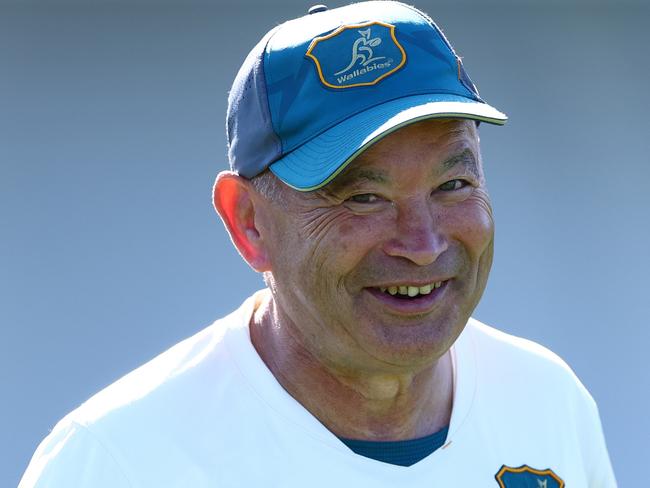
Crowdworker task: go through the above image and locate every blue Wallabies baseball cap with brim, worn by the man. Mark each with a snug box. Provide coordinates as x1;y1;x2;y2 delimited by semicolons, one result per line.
227;1;507;191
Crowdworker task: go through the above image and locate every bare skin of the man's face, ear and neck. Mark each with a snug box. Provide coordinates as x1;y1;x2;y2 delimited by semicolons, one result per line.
214;119;494;440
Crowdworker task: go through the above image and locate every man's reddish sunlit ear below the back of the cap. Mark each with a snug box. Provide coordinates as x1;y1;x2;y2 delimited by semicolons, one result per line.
212;171;270;273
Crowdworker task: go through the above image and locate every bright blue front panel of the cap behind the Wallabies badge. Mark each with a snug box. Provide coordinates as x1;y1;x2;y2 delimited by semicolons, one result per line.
265;2;479;154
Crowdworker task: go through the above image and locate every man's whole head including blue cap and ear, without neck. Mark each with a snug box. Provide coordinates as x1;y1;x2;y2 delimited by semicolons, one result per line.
215;2;505;370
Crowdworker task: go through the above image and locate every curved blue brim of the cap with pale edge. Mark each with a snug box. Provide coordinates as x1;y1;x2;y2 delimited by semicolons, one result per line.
269;94;508;191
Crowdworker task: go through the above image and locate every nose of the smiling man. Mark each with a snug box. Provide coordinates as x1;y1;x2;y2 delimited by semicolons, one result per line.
383;202;449;266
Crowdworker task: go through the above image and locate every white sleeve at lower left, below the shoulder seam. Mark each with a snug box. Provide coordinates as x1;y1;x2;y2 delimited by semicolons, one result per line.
18;421;133;488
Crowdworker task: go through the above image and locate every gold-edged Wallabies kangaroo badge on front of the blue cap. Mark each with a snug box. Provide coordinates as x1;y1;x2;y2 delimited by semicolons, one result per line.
306;22;406;88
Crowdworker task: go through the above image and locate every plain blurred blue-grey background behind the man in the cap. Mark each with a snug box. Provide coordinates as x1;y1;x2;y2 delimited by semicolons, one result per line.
0;0;650;488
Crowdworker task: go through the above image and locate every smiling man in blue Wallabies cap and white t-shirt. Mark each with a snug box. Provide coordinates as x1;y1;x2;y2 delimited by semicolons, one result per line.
21;2;616;488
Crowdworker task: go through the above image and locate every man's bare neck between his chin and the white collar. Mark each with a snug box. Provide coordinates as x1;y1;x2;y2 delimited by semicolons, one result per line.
250;299;453;440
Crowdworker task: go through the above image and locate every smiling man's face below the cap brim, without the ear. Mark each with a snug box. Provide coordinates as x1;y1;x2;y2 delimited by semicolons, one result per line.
259;119;494;371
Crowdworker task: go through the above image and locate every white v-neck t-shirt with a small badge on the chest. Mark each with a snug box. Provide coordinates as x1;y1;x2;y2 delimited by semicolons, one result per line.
19;295;616;488
